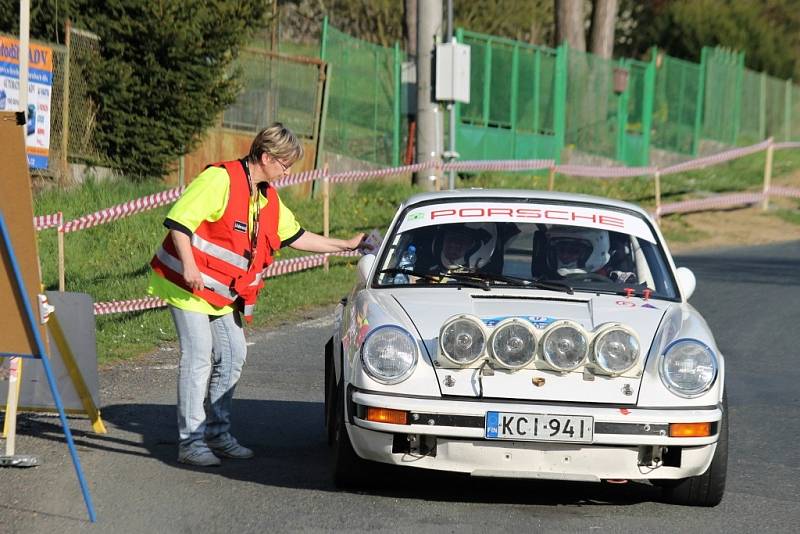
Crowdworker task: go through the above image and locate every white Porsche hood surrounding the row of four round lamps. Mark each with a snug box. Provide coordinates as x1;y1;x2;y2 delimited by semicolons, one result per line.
392;288;678;404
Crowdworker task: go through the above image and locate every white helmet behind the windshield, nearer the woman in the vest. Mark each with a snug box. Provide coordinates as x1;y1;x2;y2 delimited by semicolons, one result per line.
440;223;497;269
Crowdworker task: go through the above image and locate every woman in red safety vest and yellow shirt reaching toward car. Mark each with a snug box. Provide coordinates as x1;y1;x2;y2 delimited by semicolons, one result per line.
148;123;364;466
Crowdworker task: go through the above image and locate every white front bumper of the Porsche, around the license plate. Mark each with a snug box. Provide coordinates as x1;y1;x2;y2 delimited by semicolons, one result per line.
347;389;722;481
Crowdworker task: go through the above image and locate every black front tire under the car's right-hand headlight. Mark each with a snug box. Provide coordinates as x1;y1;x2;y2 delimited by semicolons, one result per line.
659;399;728;506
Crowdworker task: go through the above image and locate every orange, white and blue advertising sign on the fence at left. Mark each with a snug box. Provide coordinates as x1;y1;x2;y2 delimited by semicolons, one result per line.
0;35;53;169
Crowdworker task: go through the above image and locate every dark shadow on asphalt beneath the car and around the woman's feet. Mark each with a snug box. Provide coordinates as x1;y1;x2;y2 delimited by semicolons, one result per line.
24;399;660;505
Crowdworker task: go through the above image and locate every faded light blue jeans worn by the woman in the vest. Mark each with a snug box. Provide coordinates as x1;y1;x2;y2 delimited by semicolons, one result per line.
169;306;247;450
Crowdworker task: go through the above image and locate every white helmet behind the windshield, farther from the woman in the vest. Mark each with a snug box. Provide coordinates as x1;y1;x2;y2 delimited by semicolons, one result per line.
547;226;611;276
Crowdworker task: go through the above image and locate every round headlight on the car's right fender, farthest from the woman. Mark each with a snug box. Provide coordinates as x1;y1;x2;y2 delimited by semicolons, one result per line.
659;339;719;398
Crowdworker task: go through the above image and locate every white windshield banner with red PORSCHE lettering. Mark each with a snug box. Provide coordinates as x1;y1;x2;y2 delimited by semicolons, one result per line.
398;201;656;243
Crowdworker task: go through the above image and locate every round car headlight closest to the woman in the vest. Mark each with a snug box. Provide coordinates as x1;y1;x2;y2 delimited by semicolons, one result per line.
361;325;419;384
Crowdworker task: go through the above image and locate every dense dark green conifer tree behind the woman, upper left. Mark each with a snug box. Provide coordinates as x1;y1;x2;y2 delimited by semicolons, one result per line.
0;0;270;179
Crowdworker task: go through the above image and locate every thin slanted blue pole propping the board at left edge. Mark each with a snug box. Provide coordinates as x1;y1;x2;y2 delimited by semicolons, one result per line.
0;211;97;523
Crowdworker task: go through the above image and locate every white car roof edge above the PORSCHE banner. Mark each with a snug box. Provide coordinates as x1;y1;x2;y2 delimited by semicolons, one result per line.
403;188;650;218
